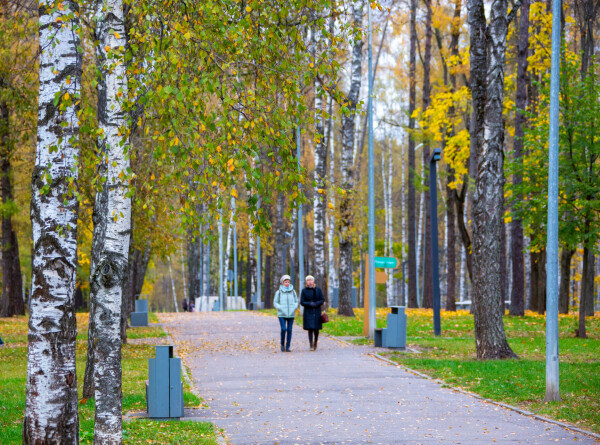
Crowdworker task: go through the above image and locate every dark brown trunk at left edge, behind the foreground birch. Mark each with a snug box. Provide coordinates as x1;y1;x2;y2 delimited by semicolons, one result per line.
0;101;25;317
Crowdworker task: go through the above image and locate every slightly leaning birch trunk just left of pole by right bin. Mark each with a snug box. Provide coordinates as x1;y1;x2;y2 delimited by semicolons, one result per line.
338;1;363;316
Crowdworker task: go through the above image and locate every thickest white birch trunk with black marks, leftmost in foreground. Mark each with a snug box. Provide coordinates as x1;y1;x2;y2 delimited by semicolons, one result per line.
23;1;81;444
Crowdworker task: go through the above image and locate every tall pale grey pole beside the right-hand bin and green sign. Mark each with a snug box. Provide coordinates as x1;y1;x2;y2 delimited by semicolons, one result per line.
367;3;377;338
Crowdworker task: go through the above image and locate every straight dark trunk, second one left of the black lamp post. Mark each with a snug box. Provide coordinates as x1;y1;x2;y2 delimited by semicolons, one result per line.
406;0;419;308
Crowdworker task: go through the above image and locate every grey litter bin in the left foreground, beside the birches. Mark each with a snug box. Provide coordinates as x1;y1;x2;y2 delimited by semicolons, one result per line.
146;345;183;419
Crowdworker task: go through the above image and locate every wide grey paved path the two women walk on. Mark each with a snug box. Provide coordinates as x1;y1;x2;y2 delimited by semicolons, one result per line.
160;312;597;445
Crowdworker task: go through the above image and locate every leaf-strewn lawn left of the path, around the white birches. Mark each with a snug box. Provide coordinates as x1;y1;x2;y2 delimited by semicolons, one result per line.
0;313;217;444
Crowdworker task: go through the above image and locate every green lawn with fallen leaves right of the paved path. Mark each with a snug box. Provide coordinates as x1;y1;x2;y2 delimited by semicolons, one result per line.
264;308;600;433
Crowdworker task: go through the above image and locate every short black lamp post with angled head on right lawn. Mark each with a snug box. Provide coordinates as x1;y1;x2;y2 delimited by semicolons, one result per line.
429;148;442;336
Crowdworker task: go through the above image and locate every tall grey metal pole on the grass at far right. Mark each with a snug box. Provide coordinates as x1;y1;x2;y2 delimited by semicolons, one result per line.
544;1;561;402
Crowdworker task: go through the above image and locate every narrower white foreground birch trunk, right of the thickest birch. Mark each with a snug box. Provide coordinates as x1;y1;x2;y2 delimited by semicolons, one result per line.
90;0;131;438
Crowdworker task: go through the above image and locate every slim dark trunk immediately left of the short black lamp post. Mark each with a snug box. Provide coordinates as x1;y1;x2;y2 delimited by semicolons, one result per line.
422;0;437;308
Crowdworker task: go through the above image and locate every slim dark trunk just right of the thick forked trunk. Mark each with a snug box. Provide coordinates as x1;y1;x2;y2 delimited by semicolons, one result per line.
509;0;530;316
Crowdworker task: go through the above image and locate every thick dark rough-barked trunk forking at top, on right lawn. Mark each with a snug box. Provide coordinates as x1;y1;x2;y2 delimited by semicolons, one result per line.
467;0;516;359
